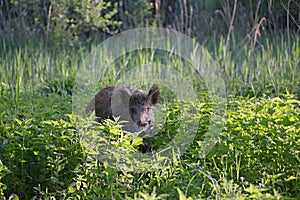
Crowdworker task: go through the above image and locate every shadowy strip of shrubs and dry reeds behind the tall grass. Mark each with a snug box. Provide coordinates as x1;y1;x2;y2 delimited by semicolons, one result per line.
0;0;299;42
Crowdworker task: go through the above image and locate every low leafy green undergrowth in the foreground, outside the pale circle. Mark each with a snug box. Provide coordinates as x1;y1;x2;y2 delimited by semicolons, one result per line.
0;82;300;199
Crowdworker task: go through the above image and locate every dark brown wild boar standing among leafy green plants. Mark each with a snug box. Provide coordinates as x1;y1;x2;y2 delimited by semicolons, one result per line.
86;85;160;135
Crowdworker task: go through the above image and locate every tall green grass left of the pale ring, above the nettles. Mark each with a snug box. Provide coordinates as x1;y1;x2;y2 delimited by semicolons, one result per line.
0;38;81;112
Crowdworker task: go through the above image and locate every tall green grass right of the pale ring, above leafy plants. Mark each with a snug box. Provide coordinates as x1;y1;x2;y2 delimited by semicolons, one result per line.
205;32;300;96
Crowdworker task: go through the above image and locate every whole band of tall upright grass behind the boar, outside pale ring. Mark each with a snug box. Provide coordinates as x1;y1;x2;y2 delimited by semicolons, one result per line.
0;33;300;97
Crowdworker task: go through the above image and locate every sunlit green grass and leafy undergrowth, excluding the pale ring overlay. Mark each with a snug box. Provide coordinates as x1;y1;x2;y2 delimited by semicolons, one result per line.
0;33;300;200
